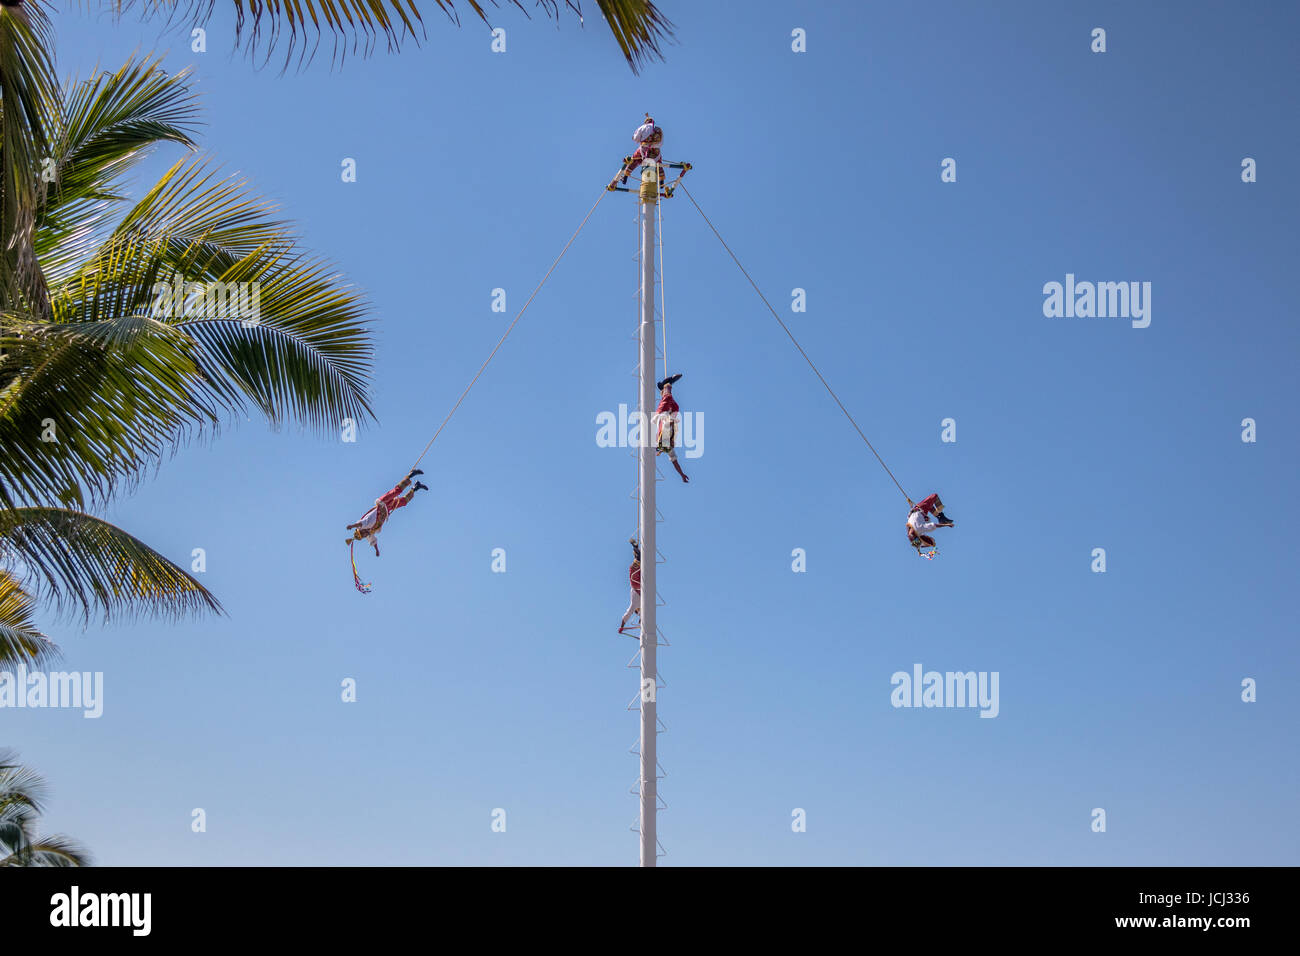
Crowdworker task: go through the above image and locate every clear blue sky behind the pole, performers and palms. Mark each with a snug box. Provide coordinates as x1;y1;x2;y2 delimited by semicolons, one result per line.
0;0;1300;865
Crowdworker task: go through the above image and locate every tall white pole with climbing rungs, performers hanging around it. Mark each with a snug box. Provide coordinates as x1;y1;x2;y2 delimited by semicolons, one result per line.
637;163;659;866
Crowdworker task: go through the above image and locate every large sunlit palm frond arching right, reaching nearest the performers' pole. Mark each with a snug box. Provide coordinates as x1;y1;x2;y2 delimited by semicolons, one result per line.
76;159;373;429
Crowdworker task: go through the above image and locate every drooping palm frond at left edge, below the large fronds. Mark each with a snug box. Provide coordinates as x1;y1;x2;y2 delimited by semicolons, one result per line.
0;507;221;623
